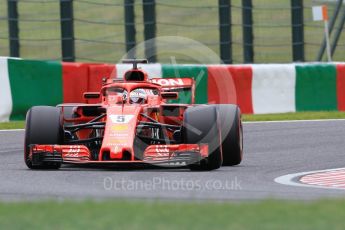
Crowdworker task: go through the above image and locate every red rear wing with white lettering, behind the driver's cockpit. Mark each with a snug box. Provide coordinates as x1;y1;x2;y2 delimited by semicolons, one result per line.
150;78;195;104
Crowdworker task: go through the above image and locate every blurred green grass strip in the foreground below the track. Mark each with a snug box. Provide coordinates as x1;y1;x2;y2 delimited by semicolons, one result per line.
0;200;345;230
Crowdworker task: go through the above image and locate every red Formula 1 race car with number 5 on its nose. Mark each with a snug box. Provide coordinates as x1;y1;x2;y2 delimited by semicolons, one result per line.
24;60;243;170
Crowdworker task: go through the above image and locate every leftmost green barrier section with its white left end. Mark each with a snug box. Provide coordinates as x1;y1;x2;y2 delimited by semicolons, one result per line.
0;58;63;121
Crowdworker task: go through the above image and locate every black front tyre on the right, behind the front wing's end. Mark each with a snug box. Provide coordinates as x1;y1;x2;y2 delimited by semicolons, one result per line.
182;105;222;171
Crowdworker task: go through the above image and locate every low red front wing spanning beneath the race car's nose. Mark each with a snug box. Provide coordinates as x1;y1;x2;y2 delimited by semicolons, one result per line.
29;144;209;166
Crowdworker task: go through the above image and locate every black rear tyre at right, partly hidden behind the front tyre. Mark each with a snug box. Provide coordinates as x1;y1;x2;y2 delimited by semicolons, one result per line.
216;104;243;166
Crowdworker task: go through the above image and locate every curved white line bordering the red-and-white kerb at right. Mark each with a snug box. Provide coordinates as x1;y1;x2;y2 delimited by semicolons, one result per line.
274;168;345;190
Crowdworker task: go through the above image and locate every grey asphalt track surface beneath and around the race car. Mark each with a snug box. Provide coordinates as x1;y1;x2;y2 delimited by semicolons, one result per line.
0;120;345;200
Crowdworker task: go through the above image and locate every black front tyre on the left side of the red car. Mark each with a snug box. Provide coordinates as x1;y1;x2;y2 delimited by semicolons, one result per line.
24;106;63;169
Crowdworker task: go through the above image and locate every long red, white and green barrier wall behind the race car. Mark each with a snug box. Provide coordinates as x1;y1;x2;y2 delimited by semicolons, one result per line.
0;57;345;121
